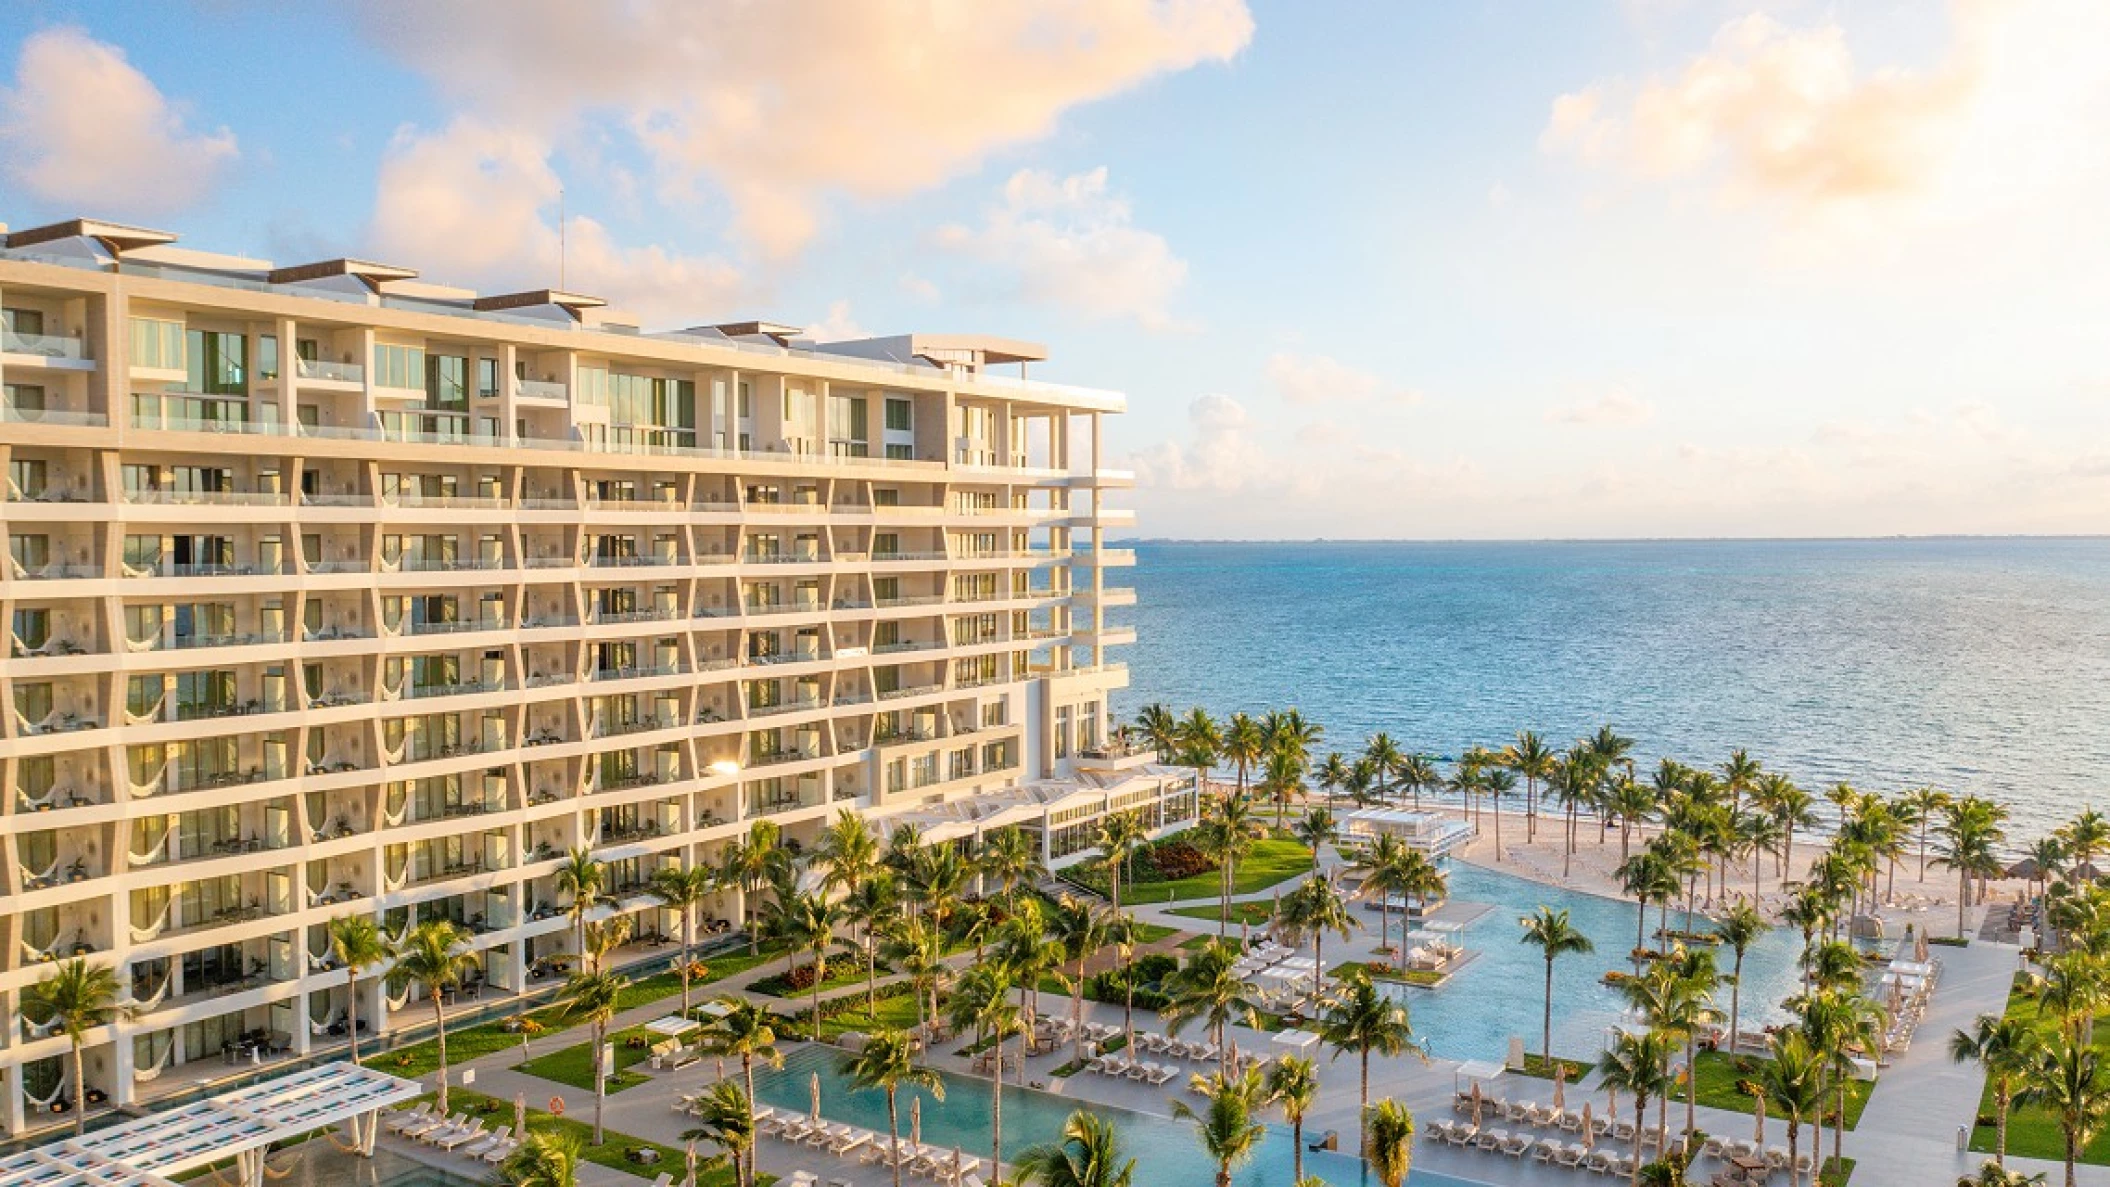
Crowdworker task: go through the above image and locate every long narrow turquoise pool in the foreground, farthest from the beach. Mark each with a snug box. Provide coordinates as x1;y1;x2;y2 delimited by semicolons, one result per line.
755;1048;1471;1187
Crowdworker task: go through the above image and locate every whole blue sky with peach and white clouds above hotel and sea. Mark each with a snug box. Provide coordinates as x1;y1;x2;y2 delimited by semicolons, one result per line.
0;0;2110;540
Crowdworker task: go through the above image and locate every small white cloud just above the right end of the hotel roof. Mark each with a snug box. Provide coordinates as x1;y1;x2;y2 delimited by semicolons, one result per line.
933;167;1186;329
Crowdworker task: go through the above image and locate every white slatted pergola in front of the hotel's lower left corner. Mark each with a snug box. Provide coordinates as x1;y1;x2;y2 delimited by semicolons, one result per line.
0;1063;422;1187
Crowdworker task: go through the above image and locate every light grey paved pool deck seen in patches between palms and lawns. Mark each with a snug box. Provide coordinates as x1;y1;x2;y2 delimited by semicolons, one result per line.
371;855;2067;1187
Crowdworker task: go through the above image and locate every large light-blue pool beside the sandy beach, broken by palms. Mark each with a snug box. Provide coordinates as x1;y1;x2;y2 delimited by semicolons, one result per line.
1384;860;1802;1060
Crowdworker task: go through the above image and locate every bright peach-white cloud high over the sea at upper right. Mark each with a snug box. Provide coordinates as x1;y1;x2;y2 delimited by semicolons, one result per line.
1540;0;2005;207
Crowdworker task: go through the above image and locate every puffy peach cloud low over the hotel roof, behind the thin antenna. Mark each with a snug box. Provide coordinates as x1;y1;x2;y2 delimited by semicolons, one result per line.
371;116;741;320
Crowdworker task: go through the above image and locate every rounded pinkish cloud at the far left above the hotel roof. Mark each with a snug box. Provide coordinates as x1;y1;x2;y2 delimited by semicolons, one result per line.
0;27;238;217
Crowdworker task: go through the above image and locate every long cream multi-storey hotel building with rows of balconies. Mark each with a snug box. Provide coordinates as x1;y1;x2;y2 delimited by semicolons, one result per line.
0;219;1194;1134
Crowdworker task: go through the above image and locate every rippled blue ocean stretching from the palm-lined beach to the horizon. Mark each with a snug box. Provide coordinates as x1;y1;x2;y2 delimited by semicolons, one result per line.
1110;540;2110;843
